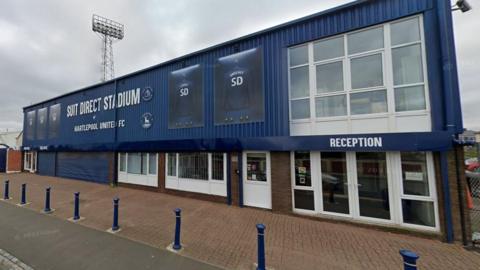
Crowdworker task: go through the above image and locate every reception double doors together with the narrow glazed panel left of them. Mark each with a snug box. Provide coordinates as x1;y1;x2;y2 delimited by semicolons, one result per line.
292;152;392;222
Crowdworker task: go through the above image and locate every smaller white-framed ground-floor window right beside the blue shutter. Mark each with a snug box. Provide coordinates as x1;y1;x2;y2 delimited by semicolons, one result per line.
118;153;158;187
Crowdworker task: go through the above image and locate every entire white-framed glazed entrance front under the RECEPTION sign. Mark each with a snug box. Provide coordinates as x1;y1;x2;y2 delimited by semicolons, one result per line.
291;151;439;231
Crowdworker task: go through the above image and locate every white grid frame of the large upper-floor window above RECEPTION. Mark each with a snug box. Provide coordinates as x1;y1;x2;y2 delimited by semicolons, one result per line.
287;14;431;135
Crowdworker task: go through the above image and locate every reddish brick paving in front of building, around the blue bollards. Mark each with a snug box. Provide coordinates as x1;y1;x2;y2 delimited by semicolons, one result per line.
0;174;480;270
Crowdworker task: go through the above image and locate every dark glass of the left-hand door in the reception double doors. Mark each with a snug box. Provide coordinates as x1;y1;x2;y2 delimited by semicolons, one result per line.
320;152;350;215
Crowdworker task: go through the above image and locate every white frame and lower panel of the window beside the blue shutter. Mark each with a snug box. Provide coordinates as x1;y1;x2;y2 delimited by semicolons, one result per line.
117;152;159;187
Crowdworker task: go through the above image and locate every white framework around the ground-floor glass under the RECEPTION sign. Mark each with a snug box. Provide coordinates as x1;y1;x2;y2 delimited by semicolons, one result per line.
290;151;440;233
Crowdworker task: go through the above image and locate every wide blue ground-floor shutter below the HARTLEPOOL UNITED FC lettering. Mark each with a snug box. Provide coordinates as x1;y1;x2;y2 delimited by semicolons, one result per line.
56;152;111;184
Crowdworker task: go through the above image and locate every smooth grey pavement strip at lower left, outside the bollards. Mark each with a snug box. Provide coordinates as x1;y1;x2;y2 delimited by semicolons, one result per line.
0;202;219;270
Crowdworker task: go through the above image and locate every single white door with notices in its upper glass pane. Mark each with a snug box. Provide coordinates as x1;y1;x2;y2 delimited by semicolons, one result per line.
243;151;272;209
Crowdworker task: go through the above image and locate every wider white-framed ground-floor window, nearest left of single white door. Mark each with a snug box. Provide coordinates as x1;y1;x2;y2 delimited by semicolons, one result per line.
165;152;227;196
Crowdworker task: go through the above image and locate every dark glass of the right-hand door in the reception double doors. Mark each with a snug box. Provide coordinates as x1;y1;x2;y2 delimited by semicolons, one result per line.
356;152;391;220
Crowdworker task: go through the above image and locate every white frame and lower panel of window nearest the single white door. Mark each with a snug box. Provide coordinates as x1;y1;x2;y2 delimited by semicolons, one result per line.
165;153;228;197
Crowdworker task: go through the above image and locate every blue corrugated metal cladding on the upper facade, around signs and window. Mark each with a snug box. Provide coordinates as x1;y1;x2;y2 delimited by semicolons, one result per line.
24;0;461;151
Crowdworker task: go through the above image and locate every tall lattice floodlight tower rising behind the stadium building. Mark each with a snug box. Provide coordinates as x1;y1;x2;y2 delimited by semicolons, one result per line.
92;14;124;82
